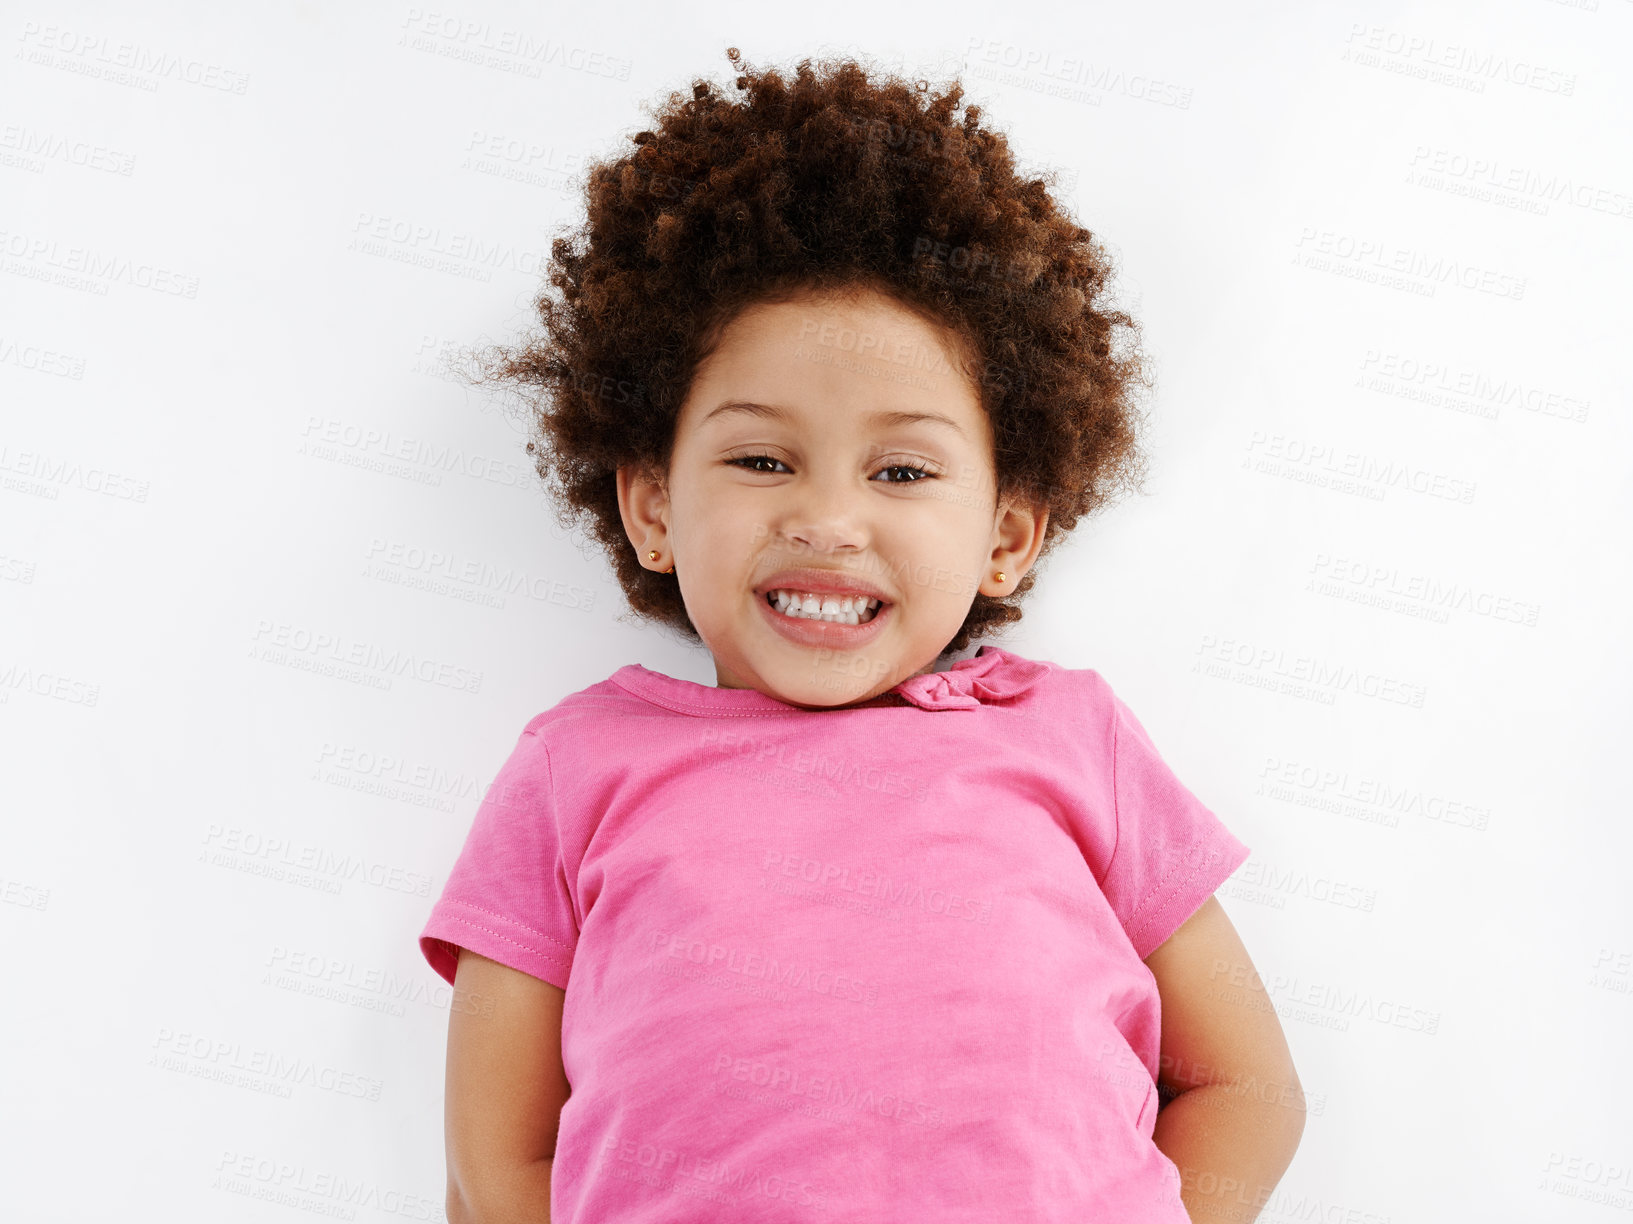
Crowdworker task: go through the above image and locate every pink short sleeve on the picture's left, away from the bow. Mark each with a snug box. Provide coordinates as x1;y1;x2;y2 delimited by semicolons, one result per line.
420;725;578;991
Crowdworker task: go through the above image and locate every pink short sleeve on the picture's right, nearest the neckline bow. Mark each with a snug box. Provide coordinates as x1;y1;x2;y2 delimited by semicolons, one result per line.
1101;694;1249;960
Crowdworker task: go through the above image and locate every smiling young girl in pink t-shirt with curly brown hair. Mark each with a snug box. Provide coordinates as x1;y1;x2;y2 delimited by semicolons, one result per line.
420;49;1303;1224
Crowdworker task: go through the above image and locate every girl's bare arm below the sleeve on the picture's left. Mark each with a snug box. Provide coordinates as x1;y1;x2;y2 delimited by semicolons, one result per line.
443;948;570;1224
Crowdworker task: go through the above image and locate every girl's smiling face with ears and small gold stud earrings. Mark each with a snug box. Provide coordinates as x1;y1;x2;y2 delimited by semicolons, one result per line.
617;294;1048;708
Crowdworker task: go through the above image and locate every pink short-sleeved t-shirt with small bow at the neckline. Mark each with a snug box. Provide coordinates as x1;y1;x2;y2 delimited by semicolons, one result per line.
420;645;1249;1224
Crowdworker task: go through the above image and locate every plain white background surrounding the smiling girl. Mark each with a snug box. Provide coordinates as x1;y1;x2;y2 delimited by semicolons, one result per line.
0;0;1633;1224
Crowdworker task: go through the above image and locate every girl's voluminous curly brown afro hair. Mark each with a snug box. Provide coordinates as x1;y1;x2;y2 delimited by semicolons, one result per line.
477;47;1151;656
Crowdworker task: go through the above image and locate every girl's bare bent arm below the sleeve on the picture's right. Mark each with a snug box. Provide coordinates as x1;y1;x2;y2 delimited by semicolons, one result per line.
1145;896;1305;1224
